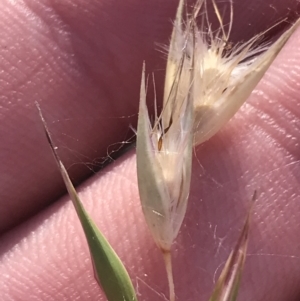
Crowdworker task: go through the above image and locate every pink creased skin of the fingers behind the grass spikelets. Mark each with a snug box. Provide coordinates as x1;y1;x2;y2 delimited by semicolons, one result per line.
0;0;300;301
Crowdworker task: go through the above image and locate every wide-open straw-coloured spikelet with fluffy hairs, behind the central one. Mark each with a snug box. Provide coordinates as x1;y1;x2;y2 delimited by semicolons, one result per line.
164;0;300;145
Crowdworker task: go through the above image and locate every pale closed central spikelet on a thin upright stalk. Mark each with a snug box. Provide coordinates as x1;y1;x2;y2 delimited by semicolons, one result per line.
136;61;193;301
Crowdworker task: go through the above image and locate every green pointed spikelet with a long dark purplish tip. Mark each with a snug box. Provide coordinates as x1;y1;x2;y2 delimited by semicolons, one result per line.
36;103;137;301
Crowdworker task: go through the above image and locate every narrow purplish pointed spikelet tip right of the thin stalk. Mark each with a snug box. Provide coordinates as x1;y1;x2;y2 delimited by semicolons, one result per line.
209;192;256;301
